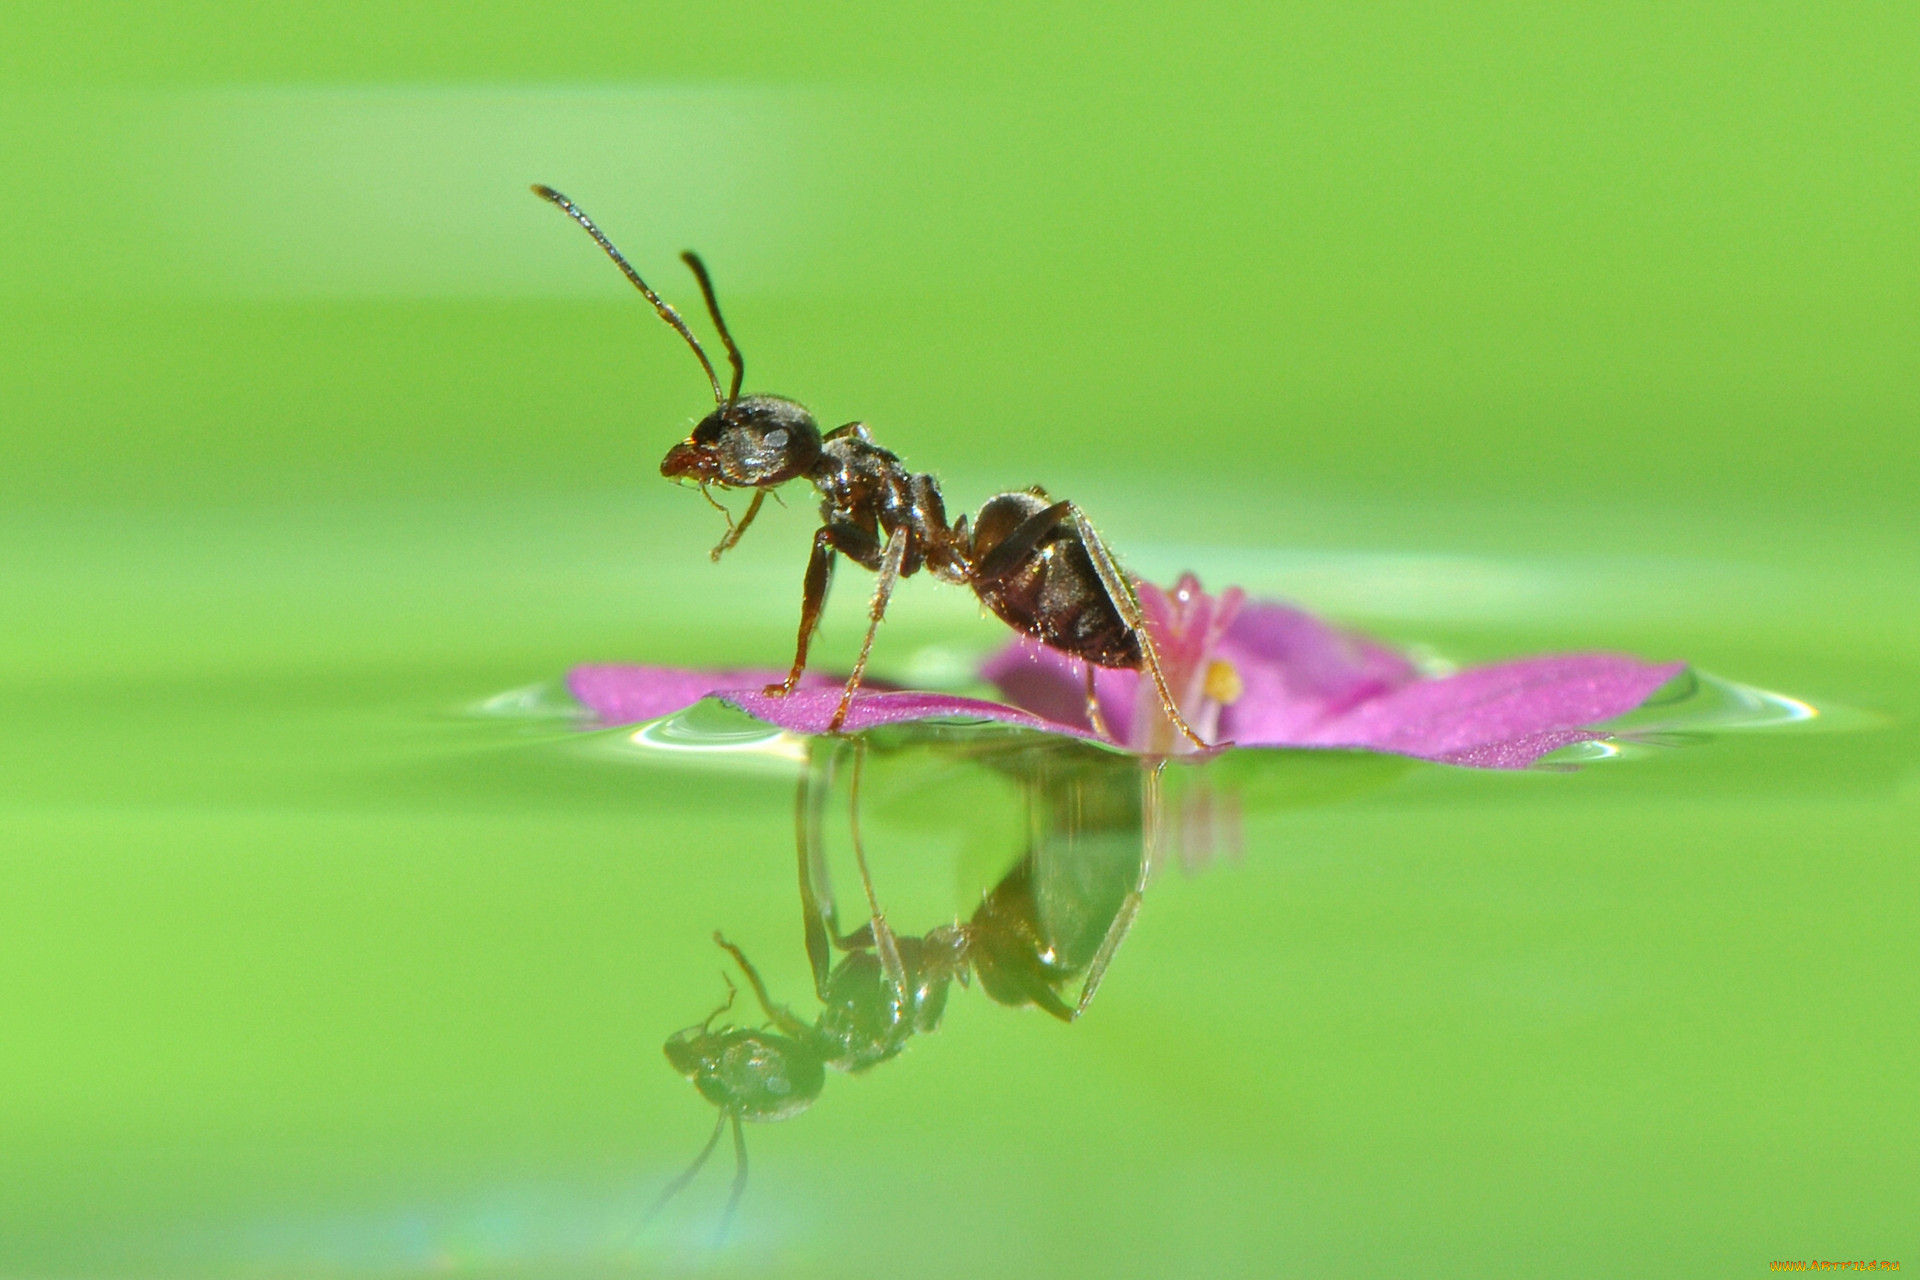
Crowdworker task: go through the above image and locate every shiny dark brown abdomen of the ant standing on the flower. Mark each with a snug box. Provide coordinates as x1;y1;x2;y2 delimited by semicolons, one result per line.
972;489;1140;670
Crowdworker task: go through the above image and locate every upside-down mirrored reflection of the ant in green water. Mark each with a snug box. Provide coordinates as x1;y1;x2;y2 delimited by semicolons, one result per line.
643;735;1162;1242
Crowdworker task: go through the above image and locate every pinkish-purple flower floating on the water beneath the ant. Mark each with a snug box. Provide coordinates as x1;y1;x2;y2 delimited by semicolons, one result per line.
566;574;1684;770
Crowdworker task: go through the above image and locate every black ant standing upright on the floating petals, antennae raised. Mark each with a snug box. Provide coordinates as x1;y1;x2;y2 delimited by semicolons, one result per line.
534;186;1208;748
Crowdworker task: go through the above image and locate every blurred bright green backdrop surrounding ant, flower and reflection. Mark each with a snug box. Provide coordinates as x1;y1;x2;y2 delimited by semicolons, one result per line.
0;4;1920;1274
